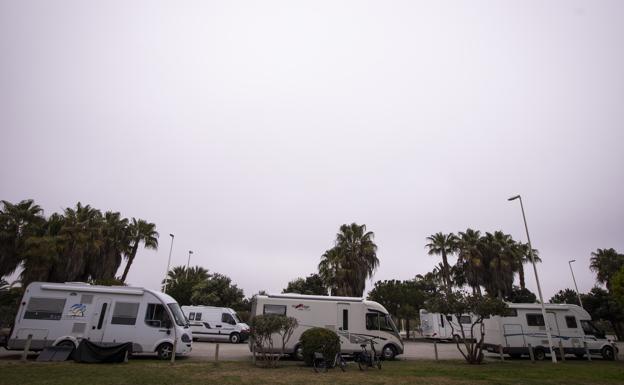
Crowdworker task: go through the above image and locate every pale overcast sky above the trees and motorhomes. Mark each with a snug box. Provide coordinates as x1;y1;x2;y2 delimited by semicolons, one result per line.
0;0;624;297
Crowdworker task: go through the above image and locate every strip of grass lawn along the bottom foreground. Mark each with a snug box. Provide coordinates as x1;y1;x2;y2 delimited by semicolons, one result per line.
0;360;624;385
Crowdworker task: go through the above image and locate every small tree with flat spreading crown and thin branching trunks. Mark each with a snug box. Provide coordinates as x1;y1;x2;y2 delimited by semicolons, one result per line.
426;292;507;364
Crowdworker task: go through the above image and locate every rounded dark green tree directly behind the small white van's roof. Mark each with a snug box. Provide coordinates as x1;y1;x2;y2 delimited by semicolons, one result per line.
191;273;245;308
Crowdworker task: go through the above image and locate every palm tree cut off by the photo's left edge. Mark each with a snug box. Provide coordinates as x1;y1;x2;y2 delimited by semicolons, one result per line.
0;199;45;277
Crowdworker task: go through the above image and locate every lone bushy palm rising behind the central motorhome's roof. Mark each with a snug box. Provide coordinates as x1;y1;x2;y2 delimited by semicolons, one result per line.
319;223;379;297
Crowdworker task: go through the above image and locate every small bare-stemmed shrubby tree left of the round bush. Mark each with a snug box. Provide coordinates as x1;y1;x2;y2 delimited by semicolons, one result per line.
250;314;298;367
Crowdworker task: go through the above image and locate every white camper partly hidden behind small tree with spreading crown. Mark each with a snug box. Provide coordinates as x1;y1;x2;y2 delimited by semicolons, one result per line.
419;309;473;340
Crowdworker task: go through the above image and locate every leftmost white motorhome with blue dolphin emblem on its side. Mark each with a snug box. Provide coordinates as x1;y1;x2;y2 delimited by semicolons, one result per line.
7;282;192;359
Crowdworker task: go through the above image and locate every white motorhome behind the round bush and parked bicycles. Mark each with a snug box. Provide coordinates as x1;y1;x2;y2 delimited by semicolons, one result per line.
249;294;403;359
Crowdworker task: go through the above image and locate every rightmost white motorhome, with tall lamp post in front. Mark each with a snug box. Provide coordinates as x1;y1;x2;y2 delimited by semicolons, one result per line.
483;303;617;360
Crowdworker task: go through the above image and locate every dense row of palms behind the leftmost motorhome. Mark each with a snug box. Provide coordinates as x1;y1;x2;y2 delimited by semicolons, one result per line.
0;199;158;287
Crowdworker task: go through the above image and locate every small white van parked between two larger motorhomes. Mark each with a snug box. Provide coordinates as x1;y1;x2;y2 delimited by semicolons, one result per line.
182;306;249;344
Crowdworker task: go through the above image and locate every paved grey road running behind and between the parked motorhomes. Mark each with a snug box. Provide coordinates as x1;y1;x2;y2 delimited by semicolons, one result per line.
0;341;624;361
